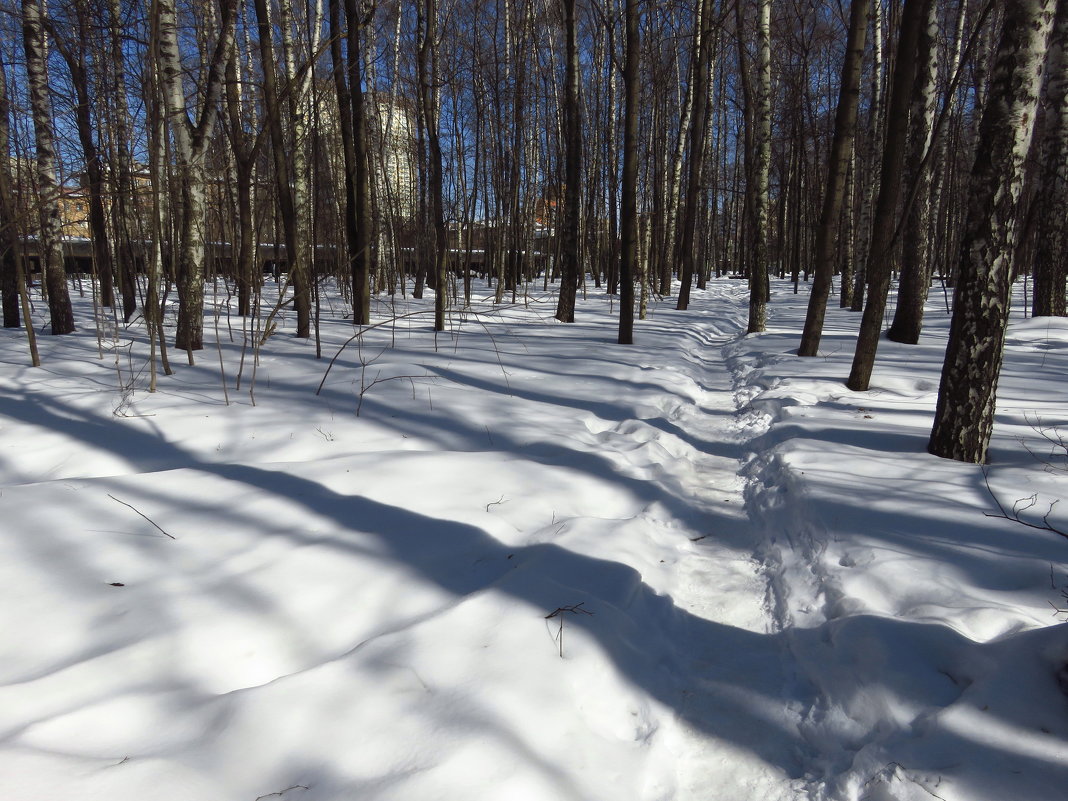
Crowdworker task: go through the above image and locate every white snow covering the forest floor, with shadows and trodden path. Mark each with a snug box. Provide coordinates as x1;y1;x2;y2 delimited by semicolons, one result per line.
0;280;1068;801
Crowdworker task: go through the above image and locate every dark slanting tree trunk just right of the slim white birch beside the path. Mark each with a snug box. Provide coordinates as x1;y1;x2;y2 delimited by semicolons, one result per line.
798;0;868;356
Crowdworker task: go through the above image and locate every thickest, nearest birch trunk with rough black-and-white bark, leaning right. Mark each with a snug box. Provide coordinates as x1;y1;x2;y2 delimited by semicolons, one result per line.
927;0;1064;464
